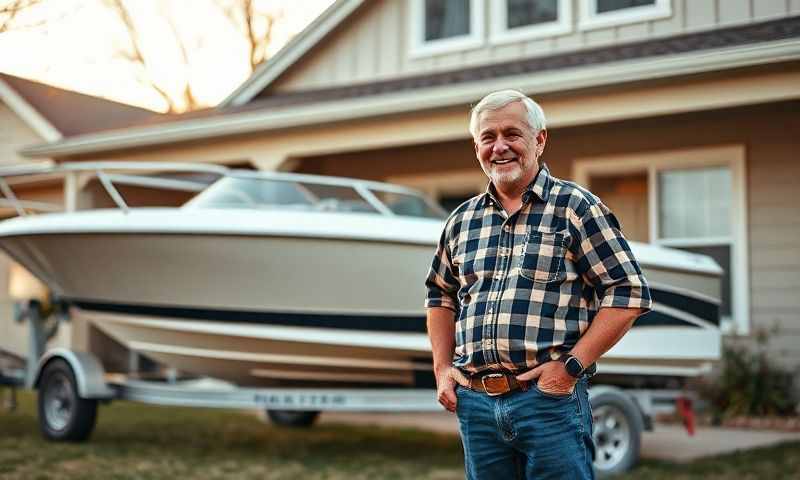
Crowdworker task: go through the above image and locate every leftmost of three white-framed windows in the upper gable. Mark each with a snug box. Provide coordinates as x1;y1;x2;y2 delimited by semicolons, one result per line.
409;0;483;57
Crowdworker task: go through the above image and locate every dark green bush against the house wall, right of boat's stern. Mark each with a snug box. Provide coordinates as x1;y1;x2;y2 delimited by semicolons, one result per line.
698;330;796;420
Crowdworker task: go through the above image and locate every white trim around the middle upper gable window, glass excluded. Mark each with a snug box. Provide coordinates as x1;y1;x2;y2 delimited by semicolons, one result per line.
489;0;572;44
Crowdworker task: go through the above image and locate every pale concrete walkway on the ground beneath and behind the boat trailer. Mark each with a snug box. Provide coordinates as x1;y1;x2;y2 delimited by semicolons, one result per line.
320;412;800;462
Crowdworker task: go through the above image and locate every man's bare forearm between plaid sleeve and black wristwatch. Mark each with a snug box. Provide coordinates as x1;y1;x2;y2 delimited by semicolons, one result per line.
571;307;642;367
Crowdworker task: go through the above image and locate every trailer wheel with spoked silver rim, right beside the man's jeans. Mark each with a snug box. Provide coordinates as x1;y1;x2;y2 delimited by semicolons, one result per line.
592;391;644;478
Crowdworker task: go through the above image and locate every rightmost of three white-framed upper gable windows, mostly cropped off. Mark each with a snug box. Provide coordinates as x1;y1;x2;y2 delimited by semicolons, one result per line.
580;0;672;30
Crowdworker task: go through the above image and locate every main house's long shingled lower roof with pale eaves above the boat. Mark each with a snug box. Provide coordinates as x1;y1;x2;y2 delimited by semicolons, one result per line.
15;15;800;157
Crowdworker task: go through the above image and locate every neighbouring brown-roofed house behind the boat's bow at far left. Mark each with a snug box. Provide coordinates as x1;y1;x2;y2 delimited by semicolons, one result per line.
0;73;159;357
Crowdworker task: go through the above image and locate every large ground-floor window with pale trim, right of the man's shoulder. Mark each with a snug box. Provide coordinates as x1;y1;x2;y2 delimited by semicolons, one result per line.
574;145;750;334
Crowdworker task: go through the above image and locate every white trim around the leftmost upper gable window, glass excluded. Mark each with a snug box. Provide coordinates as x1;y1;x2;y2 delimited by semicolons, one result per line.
408;0;484;59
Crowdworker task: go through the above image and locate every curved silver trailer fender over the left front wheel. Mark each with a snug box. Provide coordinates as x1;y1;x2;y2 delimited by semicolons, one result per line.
28;348;115;400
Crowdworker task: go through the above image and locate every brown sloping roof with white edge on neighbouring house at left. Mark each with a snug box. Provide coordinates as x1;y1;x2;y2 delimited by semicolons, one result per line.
0;73;162;141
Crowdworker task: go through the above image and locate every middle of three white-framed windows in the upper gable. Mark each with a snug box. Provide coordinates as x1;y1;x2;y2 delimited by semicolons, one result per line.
491;0;572;43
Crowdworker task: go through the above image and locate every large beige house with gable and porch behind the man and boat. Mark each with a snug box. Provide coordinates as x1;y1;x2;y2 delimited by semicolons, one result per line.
6;0;800;374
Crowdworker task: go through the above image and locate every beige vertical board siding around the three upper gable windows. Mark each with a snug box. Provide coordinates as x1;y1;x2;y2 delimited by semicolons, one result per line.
272;0;800;91
